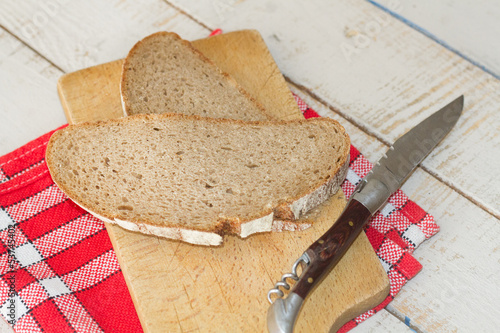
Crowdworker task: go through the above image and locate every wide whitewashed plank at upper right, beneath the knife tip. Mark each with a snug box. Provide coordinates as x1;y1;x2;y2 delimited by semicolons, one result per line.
167;0;500;217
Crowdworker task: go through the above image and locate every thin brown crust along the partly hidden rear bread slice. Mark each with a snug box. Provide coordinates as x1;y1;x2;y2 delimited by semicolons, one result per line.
120;31;276;120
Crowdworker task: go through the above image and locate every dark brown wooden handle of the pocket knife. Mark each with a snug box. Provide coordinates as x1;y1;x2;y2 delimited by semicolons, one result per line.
292;199;371;299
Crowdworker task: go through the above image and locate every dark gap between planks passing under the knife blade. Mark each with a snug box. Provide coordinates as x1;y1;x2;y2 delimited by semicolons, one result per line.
283;74;500;219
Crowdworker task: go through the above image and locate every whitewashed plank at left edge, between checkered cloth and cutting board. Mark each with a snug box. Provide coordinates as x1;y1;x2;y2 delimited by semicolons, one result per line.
0;30;66;155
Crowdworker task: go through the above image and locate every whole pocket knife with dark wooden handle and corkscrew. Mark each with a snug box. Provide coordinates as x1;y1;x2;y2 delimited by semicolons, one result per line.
267;95;464;333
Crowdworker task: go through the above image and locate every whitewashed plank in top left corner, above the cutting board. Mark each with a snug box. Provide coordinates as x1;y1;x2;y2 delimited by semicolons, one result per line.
0;0;207;72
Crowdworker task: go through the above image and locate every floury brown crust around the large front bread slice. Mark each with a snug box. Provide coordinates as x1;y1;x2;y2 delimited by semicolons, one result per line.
46;113;350;245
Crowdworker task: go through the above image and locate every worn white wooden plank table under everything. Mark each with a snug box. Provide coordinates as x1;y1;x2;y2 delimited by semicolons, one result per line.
0;0;500;332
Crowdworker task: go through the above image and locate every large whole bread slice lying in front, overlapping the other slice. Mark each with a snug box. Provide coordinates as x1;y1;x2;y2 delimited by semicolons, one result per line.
46;114;350;245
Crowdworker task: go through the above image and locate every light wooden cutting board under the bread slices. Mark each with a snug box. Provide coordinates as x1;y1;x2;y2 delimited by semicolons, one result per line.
58;31;389;332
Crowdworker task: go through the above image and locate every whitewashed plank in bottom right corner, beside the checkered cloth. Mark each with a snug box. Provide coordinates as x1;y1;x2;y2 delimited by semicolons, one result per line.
294;87;500;332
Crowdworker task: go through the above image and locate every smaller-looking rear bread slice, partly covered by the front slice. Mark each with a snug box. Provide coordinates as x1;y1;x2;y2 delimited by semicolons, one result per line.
120;32;271;120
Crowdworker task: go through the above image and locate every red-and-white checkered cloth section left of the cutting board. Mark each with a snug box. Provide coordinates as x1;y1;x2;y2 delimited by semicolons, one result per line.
0;132;142;332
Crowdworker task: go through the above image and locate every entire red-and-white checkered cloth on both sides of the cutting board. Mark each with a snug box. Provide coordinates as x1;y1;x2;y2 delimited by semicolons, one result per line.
0;96;438;332
